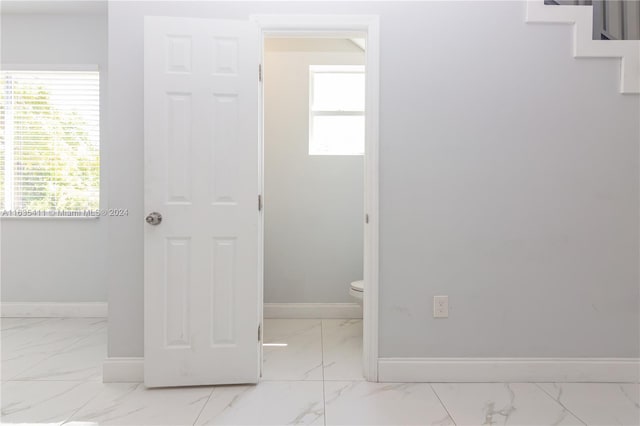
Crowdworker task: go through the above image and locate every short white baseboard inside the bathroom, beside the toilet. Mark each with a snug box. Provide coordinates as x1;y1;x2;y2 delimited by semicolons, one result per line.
264;303;362;319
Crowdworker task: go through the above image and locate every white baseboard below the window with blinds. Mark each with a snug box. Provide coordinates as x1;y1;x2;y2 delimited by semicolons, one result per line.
0;302;107;318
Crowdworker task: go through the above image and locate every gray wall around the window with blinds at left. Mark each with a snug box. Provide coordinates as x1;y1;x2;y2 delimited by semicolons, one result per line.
1;9;108;302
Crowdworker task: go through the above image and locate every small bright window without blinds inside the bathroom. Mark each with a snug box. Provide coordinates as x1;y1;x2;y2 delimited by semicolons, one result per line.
309;65;365;155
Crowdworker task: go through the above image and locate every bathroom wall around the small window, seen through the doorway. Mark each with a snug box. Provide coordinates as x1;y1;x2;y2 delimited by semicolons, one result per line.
264;38;364;303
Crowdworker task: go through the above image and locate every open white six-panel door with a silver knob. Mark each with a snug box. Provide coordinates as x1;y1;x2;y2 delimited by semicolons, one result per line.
141;17;260;387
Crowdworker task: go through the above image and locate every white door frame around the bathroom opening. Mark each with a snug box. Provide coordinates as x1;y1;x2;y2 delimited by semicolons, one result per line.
249;15;380;382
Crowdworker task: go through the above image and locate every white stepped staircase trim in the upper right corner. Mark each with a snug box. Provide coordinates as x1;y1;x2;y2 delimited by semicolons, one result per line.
527;0;640;93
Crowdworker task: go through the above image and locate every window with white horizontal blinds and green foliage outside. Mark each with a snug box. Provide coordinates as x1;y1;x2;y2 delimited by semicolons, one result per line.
0;70;100;215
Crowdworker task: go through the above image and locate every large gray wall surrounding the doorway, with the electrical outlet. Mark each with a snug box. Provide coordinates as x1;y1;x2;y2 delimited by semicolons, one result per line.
107;2;640;357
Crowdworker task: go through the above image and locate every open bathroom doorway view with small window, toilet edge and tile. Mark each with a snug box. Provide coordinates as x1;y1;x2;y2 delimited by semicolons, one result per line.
261;34;366;380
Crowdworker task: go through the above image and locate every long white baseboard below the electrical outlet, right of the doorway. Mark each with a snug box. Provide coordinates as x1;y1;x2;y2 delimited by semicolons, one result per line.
378;358;640;383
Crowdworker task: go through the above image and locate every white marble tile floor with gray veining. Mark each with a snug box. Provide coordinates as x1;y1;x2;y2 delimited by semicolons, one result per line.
0;318;640;426
